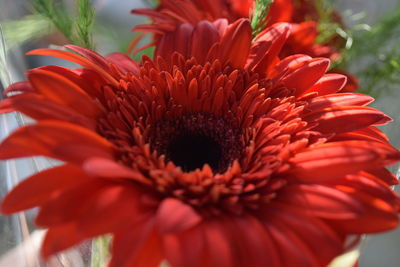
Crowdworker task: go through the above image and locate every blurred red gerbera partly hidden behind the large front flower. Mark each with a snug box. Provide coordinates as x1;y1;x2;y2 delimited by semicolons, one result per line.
132;0;358;92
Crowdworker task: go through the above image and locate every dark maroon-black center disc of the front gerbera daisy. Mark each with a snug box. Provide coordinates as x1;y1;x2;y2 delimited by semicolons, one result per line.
150;113;243;173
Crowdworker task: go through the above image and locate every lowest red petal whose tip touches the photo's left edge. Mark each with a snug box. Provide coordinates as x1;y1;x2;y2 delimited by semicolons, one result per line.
1;165;91;214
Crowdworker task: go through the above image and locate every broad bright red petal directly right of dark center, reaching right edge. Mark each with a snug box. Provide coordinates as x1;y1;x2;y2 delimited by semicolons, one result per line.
291;141;400;183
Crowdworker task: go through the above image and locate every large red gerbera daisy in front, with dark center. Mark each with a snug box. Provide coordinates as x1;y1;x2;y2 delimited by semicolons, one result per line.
0;19;400;267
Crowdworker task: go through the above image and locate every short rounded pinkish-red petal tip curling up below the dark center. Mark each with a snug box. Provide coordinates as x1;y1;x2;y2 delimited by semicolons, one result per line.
157;198;201;234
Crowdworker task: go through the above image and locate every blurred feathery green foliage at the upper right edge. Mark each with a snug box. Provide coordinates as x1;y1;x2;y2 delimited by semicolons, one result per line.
339;4;400;98
